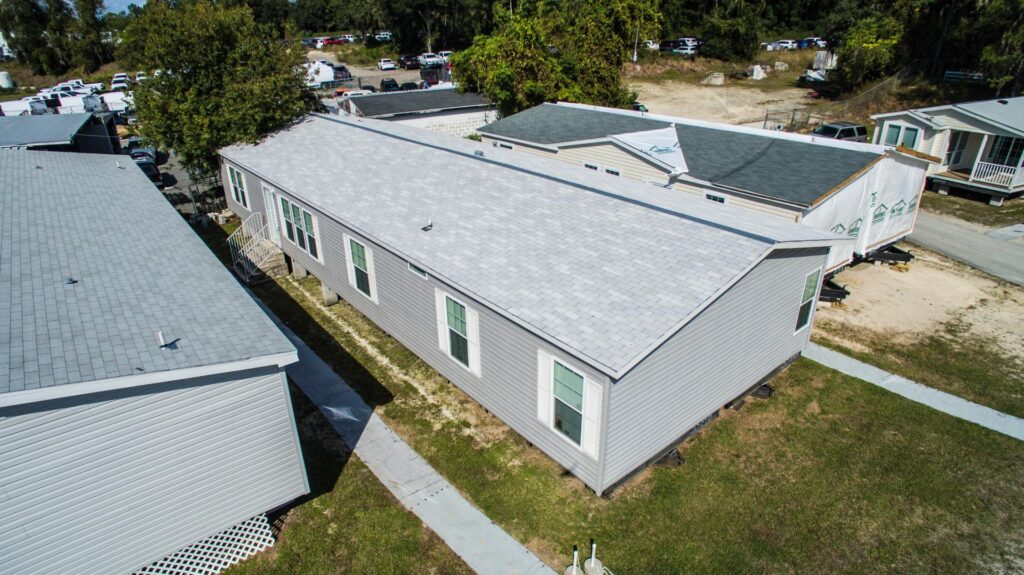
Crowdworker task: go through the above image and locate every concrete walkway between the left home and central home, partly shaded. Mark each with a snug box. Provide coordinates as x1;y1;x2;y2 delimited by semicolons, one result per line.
268;308;554;575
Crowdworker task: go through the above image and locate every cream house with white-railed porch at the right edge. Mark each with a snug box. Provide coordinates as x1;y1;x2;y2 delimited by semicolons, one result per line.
871;96;1024;206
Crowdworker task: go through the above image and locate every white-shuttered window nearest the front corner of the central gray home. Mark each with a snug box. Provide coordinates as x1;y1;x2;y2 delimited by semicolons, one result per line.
537;350;603;458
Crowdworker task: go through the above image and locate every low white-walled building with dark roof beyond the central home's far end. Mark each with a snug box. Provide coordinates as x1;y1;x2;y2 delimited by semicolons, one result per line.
339;88;498;137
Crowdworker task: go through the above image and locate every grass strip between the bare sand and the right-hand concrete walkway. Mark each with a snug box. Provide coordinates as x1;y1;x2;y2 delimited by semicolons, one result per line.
815;315;1024;417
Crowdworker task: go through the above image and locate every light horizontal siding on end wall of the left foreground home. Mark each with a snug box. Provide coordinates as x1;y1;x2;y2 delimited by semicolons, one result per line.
0;368;308;575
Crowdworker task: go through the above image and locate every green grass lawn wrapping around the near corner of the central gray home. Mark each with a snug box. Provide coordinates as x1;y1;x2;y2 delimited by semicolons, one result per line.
193;219;1024;575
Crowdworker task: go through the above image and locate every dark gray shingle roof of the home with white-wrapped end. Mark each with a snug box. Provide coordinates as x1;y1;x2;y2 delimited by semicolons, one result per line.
477;103;882;206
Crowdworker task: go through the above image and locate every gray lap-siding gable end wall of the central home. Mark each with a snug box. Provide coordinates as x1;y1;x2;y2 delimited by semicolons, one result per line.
604;250;825;487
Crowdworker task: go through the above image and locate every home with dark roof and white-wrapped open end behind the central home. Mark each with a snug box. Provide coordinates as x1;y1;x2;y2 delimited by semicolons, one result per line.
478;103;926;274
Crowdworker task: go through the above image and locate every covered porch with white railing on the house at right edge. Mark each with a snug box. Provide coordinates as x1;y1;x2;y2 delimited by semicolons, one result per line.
932;130;1024;206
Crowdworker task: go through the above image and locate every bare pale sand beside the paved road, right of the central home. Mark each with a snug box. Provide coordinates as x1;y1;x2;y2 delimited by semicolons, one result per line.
816;243;1024;361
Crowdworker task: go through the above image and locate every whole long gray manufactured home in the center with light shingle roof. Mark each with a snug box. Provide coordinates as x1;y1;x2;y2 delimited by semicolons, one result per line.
221;115;850;493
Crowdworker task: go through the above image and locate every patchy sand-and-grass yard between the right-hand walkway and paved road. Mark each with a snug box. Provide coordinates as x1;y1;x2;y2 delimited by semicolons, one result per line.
814;247;1024;417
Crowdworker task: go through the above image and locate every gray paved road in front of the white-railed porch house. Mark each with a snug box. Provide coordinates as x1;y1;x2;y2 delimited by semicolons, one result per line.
907;211;1024;285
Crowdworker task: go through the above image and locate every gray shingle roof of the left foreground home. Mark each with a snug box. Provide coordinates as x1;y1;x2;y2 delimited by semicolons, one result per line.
0;149;294;393
